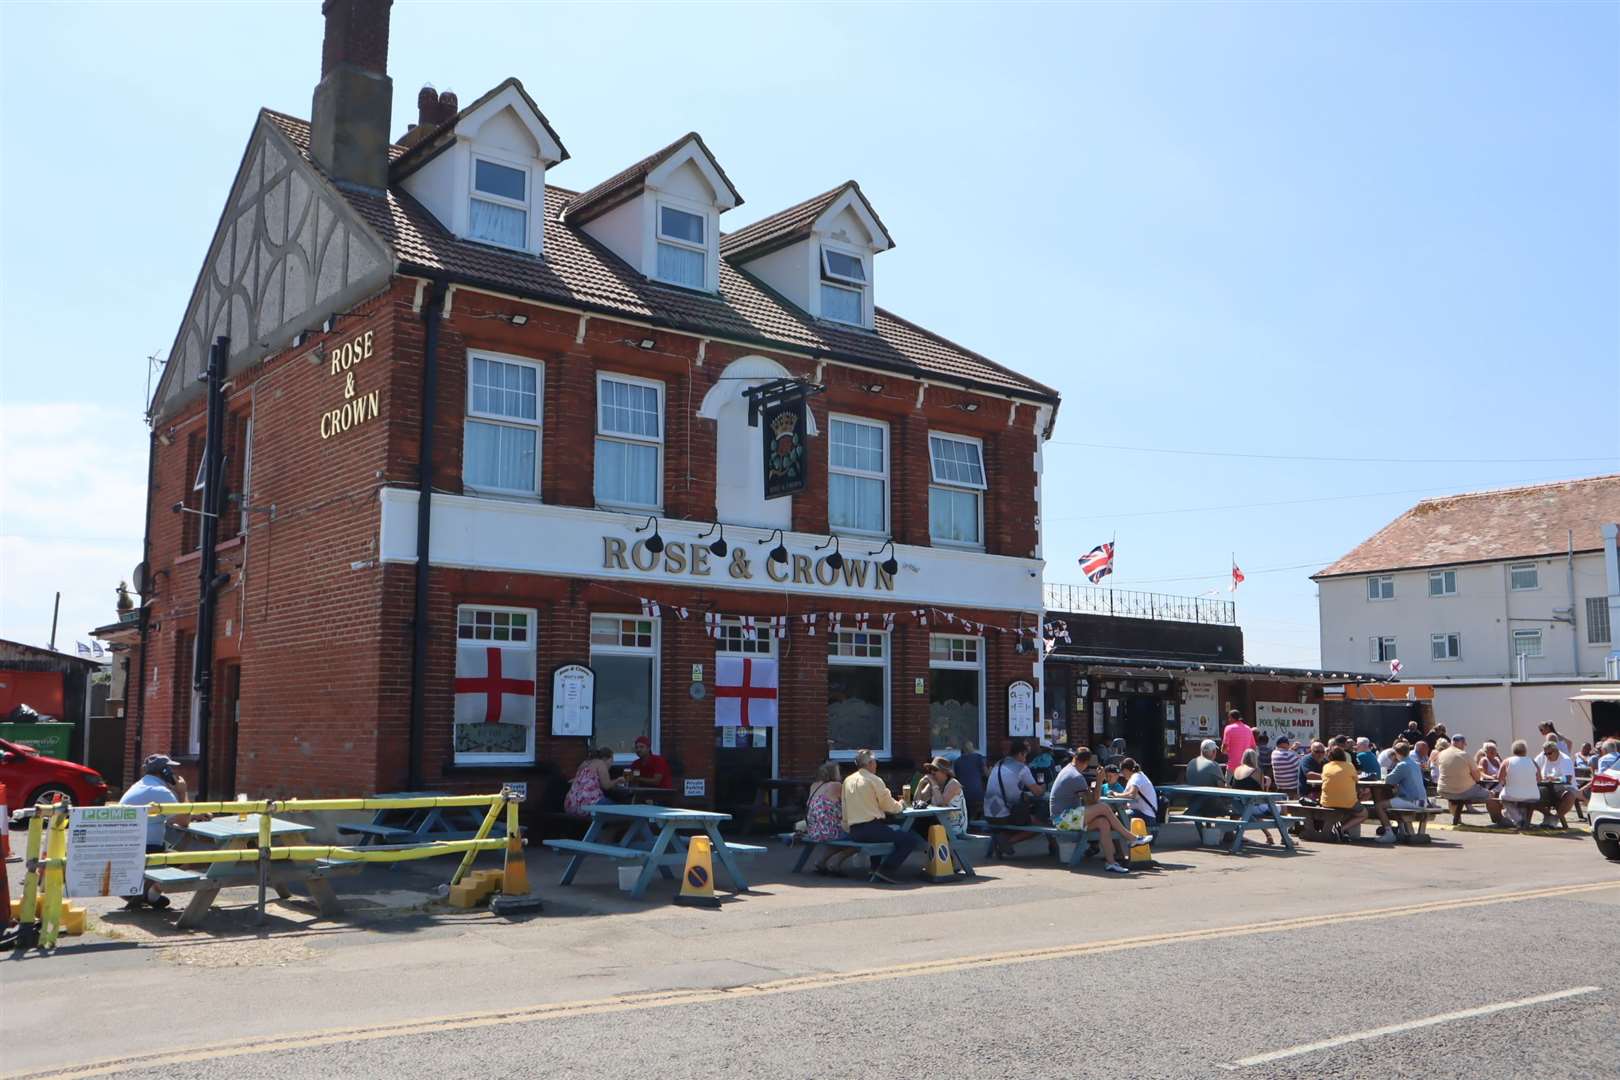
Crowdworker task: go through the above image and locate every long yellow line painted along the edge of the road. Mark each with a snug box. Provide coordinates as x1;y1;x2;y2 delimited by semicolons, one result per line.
15;881;1620;1080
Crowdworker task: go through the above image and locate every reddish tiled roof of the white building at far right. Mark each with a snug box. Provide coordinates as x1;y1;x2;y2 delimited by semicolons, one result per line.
1312;474;1620;578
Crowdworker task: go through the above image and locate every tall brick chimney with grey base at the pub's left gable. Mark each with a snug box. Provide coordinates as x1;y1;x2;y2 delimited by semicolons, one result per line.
309;0;394;191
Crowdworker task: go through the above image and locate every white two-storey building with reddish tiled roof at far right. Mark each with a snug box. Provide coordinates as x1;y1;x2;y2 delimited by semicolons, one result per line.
1312;476;1620;738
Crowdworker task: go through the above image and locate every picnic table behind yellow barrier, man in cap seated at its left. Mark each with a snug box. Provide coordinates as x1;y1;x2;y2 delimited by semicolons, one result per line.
146;814;353;929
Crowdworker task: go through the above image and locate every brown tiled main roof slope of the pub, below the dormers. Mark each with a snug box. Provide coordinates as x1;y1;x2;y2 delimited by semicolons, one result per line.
264;110;1058;403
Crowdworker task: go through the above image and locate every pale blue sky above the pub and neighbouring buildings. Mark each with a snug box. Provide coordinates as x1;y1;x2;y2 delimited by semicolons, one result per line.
0;0;1620;664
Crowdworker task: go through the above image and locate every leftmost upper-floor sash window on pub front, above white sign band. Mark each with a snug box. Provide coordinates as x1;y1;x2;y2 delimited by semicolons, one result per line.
462;353;544;495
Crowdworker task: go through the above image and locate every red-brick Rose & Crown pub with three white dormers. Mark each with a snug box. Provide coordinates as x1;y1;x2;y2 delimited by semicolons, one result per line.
126;0;1058;816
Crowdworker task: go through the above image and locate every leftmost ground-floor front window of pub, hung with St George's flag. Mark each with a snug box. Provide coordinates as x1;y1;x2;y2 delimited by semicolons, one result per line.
450;604;536;764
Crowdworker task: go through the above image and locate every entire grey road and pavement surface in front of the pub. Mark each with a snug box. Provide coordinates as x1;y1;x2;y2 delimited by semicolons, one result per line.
0;816;1620;1080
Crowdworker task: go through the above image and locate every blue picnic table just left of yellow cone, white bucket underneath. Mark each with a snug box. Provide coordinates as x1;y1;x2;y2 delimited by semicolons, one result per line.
544;801;765;900
